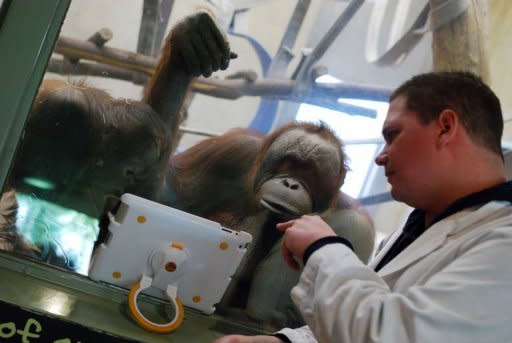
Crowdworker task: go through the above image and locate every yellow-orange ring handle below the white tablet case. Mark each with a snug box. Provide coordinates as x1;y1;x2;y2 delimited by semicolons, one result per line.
128;282;184;333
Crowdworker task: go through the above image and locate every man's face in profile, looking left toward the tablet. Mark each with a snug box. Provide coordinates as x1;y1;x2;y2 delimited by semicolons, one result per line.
375;96;439;208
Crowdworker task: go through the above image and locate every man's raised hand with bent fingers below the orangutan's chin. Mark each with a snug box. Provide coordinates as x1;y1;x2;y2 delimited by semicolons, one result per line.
276;216;336;270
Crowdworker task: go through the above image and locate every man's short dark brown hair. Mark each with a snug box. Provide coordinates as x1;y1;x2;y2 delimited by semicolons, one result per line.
390;71;503;156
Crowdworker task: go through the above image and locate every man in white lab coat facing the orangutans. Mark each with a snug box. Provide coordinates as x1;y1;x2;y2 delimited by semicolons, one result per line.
216;72;512;343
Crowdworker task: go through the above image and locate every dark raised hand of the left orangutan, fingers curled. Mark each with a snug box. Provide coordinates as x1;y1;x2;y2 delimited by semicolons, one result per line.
168;12;236;77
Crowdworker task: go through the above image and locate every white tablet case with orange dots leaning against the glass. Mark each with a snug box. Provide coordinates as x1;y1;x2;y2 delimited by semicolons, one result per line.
89;194;252;314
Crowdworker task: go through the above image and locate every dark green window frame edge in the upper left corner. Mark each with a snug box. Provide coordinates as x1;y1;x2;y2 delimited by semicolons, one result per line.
0;0;71;191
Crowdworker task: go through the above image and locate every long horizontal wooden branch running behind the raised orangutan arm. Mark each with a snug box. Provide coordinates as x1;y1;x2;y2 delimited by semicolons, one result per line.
48;37;391;115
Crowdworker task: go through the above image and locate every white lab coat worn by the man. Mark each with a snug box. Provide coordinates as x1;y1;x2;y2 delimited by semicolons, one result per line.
280;201;512;343
